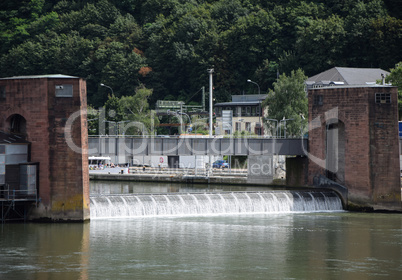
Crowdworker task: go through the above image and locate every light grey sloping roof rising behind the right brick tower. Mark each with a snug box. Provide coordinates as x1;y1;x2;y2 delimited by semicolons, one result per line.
306;67;390;85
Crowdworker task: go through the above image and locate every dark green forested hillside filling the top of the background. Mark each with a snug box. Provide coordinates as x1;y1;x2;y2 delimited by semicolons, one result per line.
0;0;402;107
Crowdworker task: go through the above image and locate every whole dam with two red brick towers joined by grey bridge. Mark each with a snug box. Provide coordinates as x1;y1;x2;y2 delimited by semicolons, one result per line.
0;74;402;222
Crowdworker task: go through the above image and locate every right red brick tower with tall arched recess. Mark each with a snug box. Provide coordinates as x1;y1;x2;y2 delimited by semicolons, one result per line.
308;86;401;210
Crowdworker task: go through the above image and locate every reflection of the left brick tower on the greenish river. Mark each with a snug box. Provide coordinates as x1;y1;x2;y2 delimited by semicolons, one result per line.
0;223;90;279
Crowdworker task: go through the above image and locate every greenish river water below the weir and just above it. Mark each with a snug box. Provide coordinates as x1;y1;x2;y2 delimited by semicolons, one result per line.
0;182;402;279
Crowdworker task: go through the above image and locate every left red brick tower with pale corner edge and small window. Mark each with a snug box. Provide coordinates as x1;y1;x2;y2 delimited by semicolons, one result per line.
0;75;90;221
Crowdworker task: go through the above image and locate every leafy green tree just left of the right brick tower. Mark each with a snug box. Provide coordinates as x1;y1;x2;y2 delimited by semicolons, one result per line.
262;69;308;137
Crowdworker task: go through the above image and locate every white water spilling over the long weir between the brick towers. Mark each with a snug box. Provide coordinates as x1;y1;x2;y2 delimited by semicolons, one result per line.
90;191;342;219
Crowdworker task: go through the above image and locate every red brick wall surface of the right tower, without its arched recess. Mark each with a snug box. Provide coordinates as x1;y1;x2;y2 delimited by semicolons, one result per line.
309;87;400;209
